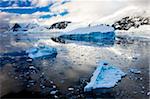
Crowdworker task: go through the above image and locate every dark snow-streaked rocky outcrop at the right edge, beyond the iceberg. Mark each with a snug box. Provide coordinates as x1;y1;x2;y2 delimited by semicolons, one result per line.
112;16;150;30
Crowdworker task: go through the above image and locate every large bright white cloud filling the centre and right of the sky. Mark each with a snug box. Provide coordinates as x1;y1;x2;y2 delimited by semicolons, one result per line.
50;0;150;22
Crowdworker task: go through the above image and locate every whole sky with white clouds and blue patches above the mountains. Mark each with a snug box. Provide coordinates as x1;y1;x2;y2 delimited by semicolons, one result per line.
0;0;150;27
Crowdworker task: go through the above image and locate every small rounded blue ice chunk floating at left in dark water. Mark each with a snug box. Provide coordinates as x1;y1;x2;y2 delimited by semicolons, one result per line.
26;46;57;59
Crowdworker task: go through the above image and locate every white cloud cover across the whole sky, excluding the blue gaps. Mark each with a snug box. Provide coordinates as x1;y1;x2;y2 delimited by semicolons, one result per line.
0;0;149;25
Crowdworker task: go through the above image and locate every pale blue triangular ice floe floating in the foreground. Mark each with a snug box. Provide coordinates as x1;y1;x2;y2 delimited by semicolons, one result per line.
84;62;126;92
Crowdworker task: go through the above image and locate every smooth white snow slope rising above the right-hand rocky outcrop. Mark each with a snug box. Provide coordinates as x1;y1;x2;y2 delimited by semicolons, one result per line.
92;6;150;25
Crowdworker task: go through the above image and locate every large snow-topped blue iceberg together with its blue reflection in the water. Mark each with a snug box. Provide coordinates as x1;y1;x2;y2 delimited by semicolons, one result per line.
54;25;115;46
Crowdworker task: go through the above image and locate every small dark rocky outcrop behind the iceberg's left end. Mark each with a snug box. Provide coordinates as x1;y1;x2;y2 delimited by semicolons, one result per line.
49;21;71;29
